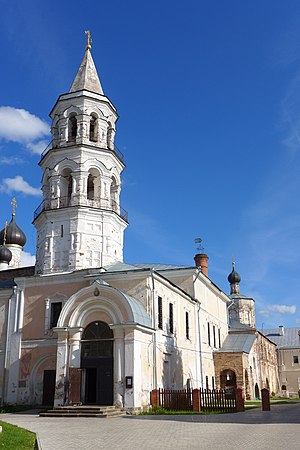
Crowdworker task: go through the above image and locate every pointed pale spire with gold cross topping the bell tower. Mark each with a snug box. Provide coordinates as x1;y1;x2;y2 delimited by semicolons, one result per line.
69;31;104;95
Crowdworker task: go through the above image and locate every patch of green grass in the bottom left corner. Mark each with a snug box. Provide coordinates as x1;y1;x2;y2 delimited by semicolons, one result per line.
0;421;35;450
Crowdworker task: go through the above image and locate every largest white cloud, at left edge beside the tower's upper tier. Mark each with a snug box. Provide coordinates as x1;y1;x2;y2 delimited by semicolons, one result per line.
0;106;50;143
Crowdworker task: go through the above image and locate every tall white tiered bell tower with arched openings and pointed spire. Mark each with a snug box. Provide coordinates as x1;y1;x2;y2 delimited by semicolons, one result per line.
33;33;128;274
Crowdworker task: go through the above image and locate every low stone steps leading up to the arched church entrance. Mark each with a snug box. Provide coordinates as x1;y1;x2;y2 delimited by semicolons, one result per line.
40;406;126;418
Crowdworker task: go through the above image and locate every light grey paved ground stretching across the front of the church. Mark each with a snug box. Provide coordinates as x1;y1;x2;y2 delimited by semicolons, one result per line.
1;403;300;450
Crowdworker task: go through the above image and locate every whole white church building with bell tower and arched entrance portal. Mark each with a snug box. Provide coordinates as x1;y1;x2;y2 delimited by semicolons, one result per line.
0;40;282;412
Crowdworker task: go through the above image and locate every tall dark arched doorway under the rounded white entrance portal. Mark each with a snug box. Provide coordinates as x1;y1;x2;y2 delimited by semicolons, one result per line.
81;321;113;405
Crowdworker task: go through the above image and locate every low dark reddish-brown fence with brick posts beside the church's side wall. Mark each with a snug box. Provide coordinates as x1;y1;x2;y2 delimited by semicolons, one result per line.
150;388;244;412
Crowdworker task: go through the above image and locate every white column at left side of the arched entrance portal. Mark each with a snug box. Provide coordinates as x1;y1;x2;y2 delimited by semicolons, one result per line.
54;328;69;406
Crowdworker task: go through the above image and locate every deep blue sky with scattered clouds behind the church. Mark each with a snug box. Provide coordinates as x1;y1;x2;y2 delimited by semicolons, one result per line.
0;0;300;328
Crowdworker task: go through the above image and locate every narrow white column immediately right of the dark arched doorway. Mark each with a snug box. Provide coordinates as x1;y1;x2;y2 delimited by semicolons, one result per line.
112;327;125;407
